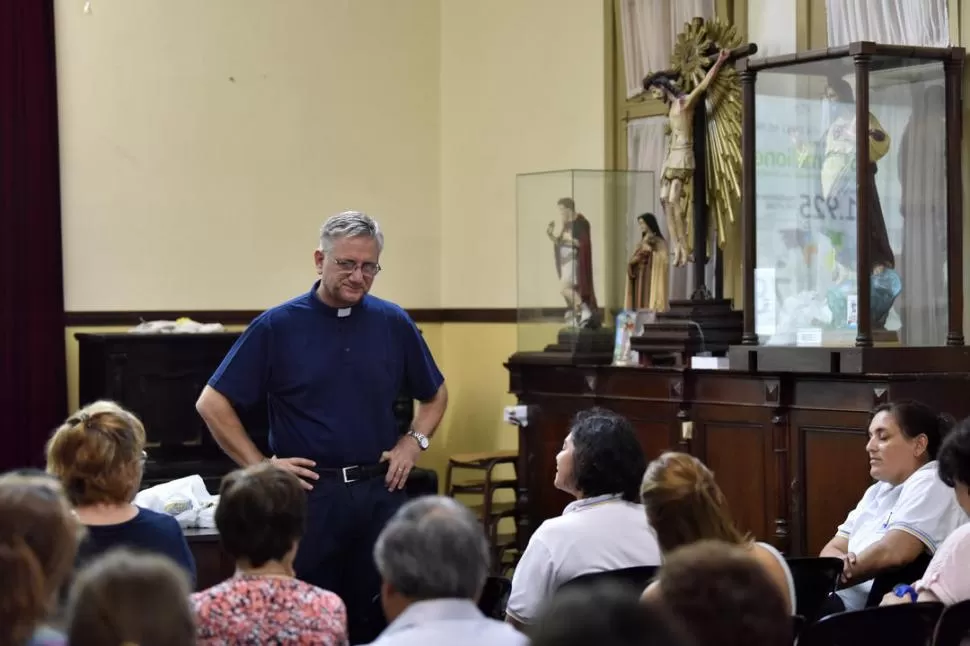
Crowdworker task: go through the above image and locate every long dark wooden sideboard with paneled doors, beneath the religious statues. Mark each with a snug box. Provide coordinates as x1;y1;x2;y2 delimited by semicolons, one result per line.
506;353;970;556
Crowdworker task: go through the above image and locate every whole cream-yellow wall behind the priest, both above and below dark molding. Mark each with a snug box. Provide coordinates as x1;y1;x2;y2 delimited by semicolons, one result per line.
56;0;606;486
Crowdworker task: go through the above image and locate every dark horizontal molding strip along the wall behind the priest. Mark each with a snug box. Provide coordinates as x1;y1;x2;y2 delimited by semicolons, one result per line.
64;307;524;327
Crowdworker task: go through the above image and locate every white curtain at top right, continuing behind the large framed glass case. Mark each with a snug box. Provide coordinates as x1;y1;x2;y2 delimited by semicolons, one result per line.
826;0;944;345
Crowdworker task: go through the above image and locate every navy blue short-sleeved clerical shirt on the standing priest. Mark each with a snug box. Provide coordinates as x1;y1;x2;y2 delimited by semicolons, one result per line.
209;282;444;468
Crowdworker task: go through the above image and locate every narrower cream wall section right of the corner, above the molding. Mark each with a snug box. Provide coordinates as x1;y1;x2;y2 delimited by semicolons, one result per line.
441;0;606;307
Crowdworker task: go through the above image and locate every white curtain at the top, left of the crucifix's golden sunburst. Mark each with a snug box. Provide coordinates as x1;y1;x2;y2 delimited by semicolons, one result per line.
620;0;714;98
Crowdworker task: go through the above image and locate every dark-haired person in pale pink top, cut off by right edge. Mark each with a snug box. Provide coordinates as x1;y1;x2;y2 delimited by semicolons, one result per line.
882;418;970;606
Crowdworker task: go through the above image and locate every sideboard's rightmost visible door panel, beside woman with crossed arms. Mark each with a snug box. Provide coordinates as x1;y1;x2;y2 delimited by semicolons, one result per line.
790;410;872;556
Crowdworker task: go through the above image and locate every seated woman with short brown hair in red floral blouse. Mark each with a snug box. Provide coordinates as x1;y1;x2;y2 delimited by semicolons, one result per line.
192;462;347;646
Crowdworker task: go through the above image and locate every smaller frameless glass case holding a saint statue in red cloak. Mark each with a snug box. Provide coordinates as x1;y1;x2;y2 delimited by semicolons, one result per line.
516;170;656;361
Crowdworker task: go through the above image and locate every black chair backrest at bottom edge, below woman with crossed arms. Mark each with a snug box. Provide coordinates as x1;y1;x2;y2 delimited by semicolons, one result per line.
798;603;943;646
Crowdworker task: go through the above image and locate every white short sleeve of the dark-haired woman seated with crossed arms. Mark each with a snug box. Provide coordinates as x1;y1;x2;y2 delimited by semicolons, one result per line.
885;469;962;554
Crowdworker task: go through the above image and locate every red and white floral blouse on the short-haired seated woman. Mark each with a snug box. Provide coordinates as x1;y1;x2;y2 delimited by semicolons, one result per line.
192;575;347;646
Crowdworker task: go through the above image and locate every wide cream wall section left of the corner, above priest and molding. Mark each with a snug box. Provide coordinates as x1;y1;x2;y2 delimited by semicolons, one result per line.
55;0;441;311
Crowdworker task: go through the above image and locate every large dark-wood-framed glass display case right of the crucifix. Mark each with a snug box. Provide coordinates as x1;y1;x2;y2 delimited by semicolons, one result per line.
739;43;964;347
